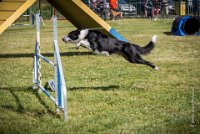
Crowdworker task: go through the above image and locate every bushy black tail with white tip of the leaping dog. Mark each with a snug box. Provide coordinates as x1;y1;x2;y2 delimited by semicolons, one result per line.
136;35;157;55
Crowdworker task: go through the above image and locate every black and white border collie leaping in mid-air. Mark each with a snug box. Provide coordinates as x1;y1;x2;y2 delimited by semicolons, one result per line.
62;29;159;71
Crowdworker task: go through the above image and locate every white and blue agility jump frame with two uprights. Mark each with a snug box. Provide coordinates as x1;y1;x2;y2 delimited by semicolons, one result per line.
33;14;68;121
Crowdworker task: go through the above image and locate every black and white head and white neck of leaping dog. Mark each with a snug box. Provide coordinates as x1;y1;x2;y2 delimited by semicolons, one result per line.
62;29;89;43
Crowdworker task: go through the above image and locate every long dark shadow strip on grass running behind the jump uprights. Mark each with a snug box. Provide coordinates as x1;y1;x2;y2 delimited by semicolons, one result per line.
0;52;94;58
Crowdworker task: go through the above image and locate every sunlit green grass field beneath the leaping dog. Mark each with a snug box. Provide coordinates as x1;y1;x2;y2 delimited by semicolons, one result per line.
0;19;200;134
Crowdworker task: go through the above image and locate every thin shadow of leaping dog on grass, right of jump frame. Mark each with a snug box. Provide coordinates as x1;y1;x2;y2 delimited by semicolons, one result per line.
68;85;119;91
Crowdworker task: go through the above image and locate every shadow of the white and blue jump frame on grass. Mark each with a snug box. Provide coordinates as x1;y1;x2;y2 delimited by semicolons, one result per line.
0;87;60;118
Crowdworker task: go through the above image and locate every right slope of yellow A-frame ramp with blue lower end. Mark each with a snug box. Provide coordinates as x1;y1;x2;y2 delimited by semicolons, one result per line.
47;0;126;41
